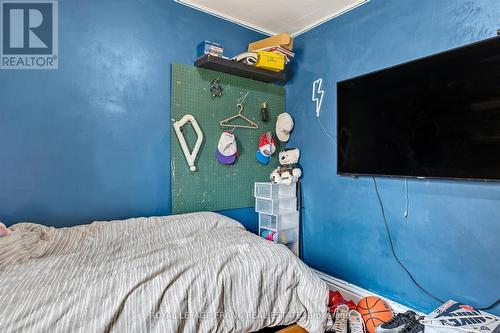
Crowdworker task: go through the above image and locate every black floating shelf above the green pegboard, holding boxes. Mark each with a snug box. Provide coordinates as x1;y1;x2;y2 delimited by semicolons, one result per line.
194;54;286;83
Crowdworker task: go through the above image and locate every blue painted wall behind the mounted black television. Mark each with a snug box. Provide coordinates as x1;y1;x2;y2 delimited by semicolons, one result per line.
287;0;500;314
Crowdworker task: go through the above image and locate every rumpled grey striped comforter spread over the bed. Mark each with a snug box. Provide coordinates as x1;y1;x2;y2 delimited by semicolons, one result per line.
0;213;327;333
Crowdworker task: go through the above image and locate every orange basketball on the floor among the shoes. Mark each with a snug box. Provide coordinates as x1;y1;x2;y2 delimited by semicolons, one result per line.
356;296;392;333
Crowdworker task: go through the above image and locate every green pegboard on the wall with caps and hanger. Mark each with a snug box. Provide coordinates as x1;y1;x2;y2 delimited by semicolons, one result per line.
170;64;285;214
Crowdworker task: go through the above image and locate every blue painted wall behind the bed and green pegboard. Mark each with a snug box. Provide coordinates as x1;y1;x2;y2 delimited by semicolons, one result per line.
0;0;262;229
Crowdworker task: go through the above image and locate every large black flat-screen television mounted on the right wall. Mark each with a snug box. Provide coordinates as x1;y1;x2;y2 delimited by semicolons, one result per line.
337;37;500;180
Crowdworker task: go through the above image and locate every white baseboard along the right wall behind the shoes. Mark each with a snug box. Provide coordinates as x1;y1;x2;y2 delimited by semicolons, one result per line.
313;269;423;315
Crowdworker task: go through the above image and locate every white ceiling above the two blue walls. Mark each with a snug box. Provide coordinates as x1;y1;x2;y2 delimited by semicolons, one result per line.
175;0;369;36
